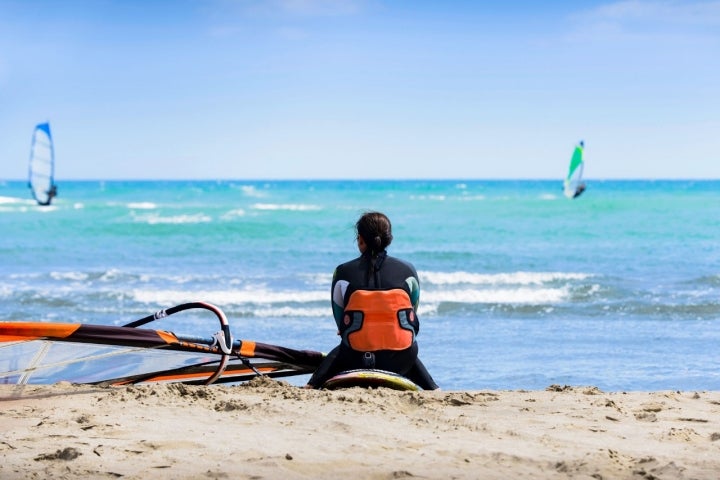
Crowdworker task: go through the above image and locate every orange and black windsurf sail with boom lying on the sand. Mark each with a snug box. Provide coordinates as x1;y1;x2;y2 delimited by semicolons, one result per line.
0;302;324;385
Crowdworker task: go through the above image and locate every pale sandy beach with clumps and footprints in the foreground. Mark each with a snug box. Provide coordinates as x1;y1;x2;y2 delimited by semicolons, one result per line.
0;378;720;480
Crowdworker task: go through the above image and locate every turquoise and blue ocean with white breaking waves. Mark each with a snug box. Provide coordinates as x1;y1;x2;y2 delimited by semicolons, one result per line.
0;180;720;391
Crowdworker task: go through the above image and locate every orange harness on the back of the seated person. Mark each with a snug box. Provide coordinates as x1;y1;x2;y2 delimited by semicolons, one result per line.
342;288;417;352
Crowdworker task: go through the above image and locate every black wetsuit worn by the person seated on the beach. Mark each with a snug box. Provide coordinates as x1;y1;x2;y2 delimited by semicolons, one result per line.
308;252;438;390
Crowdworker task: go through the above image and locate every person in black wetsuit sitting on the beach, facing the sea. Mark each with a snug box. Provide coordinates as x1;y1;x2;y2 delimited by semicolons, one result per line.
305;212;438;390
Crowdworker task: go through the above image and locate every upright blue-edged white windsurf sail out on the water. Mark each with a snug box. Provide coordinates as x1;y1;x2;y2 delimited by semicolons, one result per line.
28;122;57;205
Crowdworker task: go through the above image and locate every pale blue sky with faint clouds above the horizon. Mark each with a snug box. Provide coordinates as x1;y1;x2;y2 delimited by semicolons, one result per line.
0;0;720;181
